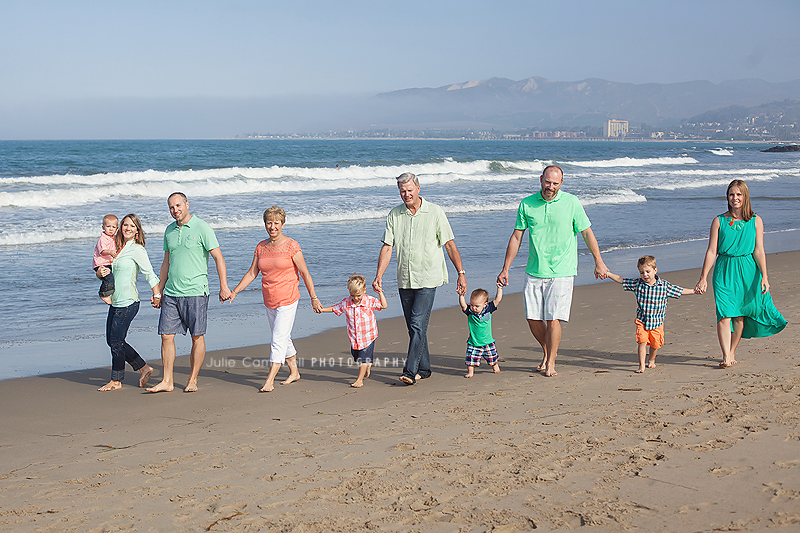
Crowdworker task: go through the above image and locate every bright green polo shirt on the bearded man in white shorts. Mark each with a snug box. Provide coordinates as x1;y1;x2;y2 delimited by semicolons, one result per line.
514;191;592;278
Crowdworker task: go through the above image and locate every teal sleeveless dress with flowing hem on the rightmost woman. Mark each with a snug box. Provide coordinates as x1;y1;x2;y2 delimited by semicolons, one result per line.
714;215;786;339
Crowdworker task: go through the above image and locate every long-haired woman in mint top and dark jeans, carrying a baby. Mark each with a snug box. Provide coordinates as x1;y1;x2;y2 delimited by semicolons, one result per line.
97;214;161;391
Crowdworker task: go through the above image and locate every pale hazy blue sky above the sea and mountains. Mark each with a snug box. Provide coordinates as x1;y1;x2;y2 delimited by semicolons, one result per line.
0;0;800;139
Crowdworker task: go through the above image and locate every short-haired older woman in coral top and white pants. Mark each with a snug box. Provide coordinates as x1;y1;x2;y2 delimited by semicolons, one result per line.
230;205;322;392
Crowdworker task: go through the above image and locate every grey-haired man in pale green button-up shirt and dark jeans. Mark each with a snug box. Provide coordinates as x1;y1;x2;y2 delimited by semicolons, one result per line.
372;172;467;385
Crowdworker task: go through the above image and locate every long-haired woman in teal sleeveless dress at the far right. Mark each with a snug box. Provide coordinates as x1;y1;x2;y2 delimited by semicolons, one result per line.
696;180;786;368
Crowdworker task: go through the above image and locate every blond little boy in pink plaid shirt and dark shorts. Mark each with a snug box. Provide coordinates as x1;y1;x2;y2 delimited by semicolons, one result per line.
321;274;388;387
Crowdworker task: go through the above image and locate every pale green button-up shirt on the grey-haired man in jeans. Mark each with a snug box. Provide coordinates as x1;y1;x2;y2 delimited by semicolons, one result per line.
382;199;453;289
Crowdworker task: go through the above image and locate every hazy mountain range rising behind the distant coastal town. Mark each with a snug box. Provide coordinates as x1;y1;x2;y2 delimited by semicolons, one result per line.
371;77;800;128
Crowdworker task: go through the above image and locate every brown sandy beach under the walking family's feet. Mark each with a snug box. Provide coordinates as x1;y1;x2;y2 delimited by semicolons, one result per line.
0;252;800;532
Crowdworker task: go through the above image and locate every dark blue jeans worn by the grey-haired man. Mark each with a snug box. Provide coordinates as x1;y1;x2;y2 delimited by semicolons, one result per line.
400;287;436;382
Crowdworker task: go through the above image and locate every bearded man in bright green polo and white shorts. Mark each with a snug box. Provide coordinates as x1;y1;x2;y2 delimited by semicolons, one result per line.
497;165;608;376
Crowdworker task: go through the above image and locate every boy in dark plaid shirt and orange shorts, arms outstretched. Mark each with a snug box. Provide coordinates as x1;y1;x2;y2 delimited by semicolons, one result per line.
608;255;695;374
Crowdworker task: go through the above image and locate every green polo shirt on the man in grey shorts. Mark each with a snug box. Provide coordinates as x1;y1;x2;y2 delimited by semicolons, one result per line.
164;216;219;297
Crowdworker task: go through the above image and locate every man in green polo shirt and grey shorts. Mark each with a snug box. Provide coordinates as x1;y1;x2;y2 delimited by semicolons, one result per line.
147;192;231;392
